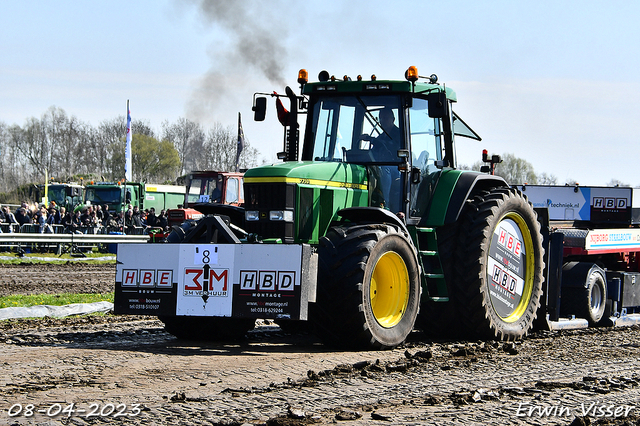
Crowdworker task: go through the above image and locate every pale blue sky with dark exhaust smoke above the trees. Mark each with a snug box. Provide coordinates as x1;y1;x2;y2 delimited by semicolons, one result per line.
0;0;640;186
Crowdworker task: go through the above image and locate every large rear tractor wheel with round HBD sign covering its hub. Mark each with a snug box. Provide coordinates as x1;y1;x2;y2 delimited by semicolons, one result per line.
452;188;544;340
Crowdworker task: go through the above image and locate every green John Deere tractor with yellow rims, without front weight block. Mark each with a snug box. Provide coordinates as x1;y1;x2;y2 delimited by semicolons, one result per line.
241;67;544;348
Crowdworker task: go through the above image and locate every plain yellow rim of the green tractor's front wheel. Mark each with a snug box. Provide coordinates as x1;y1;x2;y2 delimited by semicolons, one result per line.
369;251;409;328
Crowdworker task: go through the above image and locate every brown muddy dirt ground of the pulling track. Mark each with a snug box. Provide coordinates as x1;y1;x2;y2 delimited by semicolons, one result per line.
0;263;640;426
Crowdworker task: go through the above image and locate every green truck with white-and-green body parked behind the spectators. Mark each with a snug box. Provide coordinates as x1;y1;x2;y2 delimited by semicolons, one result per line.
84;182;185;213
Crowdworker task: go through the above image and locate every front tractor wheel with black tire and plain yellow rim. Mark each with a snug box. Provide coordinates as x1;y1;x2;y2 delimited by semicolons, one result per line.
311;224;421;349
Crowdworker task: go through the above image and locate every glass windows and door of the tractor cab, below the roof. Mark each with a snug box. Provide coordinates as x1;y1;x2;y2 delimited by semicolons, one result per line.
302;92;443;213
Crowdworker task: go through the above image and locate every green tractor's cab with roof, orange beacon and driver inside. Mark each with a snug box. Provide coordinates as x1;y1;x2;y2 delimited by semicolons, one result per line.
299;67;480;217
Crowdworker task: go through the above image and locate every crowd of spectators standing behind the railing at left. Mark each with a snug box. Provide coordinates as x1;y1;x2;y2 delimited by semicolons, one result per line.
0;201;169;234
